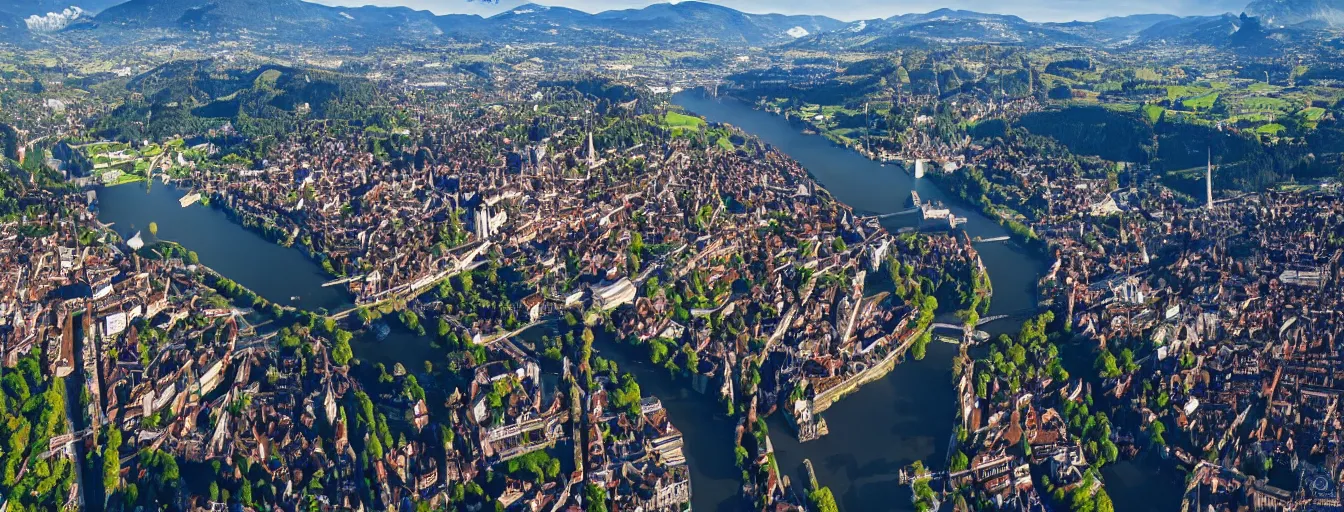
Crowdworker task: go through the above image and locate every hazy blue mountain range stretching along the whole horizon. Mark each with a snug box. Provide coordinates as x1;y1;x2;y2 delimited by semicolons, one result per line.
0;0;1344;51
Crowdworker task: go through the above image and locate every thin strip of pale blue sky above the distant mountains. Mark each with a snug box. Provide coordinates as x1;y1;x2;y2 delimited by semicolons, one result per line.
310;0;1249;22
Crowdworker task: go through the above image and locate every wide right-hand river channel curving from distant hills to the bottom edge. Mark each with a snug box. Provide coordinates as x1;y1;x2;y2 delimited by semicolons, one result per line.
672;91;1046;511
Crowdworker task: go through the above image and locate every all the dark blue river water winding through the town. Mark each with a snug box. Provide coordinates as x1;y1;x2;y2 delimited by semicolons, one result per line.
98;93;1171;512
